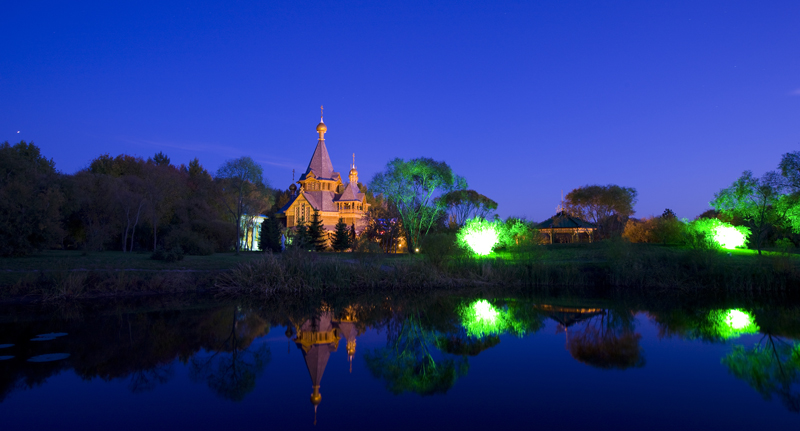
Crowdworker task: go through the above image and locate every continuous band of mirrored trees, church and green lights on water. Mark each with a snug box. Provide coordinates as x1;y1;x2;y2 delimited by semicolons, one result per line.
0;297;800;422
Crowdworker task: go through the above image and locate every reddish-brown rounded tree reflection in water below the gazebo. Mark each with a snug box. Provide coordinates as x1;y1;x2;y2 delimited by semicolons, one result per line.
567;310;644;370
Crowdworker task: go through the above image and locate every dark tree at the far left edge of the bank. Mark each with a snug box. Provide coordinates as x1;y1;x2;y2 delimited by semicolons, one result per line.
0;141;65;256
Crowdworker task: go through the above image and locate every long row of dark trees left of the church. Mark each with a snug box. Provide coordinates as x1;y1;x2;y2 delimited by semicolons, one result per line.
0;141;276;256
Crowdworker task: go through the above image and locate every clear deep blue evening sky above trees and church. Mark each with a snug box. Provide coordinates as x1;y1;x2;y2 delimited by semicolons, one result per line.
0;0;800;221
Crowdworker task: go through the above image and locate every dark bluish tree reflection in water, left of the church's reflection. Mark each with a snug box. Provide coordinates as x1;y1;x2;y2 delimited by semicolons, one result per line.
190;308;271;401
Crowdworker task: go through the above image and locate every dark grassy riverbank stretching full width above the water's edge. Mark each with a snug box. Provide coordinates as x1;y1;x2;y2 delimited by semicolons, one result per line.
0;242;800;302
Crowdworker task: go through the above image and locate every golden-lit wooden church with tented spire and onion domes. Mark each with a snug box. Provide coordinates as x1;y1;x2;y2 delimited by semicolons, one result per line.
276;109;369;234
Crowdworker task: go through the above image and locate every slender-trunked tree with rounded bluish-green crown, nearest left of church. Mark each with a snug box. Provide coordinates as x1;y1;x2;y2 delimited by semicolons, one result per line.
217;156;264;254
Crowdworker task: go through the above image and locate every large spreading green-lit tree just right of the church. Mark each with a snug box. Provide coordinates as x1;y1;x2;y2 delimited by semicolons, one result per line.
370;158;467;250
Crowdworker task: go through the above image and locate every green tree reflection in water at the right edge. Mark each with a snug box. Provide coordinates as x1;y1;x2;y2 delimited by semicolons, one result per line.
722;335;800;412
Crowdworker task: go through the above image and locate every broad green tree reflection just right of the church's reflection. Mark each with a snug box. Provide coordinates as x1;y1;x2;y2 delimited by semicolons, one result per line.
364;314;469;395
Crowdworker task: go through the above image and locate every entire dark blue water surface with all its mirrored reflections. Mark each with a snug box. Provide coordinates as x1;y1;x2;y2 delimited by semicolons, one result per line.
0;296;800;430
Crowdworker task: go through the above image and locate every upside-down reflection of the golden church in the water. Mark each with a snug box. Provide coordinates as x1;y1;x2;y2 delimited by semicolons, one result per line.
287;307;358;424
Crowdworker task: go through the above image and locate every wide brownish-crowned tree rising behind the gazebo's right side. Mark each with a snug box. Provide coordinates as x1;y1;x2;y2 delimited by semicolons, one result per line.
565;184;638;235
